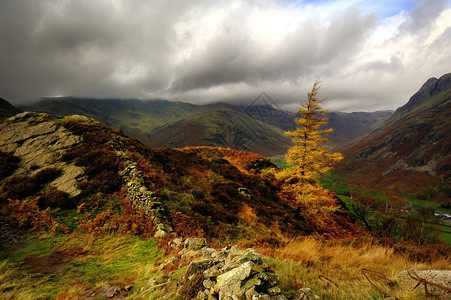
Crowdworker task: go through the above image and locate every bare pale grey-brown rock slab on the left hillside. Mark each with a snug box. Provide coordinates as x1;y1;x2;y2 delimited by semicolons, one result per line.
0;112;84;197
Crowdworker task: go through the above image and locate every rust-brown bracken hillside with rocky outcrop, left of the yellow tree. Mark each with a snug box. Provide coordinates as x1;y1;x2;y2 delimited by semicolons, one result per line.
0;112;354;240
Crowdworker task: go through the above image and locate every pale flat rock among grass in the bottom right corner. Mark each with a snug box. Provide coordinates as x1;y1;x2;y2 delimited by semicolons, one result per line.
398;270;451;299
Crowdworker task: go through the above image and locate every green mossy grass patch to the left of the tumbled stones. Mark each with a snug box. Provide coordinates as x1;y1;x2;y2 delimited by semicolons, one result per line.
0;234;163;299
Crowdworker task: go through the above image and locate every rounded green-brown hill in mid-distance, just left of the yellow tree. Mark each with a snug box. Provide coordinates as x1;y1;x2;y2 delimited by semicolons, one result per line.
148;108;291;156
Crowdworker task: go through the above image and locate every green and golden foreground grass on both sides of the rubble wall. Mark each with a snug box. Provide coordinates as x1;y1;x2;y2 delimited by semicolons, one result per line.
0;224;450;300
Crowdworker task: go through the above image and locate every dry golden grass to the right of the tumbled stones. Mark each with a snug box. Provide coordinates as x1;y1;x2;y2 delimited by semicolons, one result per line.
258;237;451;299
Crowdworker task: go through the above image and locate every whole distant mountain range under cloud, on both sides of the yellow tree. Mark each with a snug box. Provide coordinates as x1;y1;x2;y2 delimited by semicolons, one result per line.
23;97;391;156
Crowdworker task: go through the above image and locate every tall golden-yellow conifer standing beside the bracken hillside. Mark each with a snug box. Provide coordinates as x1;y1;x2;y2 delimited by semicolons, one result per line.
279;81;343;195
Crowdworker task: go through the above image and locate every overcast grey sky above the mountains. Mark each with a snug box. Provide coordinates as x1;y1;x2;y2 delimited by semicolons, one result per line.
0;0;451;111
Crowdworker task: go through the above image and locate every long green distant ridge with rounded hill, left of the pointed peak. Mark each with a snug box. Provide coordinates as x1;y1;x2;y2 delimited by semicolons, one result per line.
24;97;290;156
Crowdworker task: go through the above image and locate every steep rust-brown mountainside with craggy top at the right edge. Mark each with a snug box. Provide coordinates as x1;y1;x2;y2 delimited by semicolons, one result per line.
338;73;451;192
